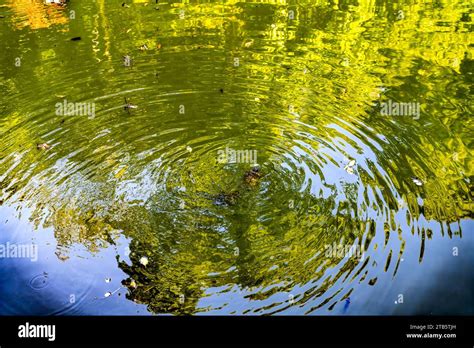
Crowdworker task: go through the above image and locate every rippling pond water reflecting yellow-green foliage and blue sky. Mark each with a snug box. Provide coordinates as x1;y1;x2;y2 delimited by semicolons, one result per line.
0;0;474;315
